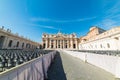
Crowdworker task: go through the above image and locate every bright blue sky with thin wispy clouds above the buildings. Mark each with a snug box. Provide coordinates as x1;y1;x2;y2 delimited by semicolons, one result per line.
0;0;120;42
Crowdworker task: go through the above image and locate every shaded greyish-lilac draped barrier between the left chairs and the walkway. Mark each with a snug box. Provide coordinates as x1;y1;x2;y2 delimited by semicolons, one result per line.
0;51;56;80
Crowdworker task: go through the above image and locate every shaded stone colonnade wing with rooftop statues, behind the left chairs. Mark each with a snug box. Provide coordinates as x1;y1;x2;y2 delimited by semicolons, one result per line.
0;27;40;49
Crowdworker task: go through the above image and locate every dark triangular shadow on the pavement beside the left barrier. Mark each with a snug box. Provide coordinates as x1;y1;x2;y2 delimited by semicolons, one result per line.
48;52;67;80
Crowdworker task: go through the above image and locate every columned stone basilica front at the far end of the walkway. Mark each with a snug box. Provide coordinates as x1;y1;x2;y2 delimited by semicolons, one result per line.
42;32;78;49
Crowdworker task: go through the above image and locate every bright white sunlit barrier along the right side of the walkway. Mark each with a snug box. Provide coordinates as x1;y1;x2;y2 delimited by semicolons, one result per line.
64;50;120;78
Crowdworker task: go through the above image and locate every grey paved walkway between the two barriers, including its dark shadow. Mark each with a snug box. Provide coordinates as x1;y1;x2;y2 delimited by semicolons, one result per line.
48;51;115;80
